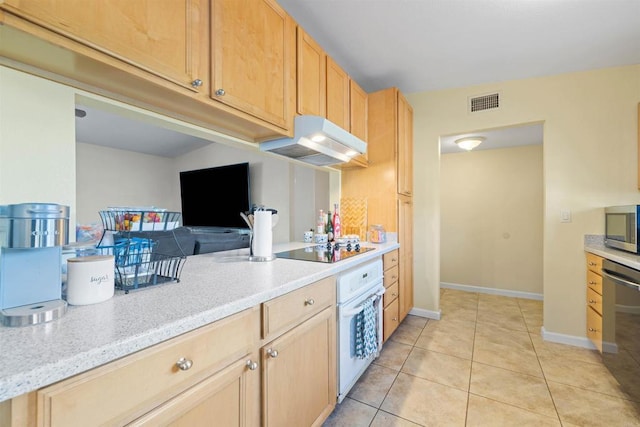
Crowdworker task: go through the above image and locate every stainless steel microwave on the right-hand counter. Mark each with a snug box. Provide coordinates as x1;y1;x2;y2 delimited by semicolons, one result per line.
604;205;640;253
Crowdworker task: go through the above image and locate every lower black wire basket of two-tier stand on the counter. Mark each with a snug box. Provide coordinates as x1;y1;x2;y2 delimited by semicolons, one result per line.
97;237;187;293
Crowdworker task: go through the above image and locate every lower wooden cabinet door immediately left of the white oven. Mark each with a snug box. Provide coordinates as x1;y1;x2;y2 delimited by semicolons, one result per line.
262;306;337;427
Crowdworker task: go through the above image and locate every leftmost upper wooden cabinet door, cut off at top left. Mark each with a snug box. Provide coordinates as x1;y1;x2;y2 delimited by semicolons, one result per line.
0;0;202;91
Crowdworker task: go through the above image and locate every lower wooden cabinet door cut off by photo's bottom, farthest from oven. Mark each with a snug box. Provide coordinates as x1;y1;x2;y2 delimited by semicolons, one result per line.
130;352;260;427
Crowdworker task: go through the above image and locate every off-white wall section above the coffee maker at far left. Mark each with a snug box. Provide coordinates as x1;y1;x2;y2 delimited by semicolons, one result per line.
0;67;76;224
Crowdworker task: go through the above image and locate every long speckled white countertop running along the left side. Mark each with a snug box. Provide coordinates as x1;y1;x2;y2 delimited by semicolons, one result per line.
0;242;399;402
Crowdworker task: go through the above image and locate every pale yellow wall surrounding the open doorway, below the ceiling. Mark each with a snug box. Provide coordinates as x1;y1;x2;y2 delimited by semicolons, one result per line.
407;65;640;342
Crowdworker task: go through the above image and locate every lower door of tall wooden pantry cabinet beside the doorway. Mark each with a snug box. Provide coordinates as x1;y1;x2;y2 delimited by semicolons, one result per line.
398;196;413;322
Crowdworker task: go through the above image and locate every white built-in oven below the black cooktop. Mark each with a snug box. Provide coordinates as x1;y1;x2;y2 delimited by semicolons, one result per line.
337;259;385;403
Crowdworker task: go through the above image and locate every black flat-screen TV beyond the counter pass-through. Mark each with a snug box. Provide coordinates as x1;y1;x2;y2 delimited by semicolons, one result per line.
180;163;251;228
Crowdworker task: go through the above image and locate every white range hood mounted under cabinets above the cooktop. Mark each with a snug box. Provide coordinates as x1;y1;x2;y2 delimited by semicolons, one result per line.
260;116;367;166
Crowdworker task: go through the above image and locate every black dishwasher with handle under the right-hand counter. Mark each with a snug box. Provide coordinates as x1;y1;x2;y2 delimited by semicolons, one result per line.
602;259;640;404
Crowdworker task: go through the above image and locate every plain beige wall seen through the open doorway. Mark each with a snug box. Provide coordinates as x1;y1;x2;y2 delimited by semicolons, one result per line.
440;145;544;296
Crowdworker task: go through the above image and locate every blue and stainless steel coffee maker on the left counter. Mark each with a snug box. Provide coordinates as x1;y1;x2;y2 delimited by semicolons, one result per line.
0;203;69;326
